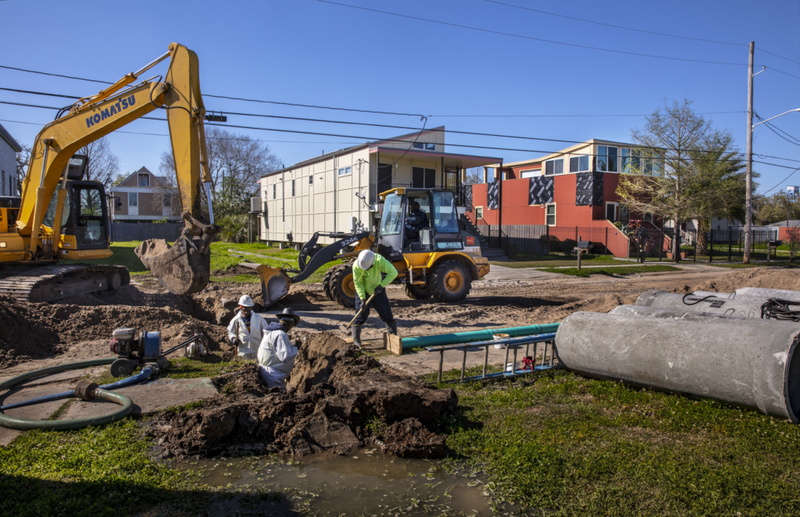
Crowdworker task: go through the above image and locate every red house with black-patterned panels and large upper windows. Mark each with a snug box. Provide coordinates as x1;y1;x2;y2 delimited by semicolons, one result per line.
466;139;663;257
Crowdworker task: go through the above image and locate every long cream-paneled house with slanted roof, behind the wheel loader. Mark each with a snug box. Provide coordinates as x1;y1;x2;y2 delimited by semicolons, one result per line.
252;126;501;243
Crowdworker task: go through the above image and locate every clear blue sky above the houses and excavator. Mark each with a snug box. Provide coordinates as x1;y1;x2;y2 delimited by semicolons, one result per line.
0;0;800;194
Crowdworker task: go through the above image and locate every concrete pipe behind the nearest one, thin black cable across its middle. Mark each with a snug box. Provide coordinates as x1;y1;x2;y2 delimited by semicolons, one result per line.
636;289;767;319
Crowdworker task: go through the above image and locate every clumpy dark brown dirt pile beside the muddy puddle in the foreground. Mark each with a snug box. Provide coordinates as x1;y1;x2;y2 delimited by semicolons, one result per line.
147;332;458;458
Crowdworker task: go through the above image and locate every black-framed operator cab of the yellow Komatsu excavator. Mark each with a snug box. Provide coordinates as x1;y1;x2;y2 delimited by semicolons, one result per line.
42;155;109;250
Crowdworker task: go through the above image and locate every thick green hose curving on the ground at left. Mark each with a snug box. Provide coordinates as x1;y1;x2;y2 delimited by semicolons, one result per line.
0;357;133;431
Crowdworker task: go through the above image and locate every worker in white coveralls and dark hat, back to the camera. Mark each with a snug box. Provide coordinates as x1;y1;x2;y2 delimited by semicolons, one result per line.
258;307;300;391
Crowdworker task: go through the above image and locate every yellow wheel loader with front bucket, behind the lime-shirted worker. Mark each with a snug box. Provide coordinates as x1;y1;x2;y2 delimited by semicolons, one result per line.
258;188;489;307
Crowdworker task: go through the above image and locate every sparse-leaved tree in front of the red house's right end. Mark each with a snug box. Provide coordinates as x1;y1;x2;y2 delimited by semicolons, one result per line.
617;99;731;262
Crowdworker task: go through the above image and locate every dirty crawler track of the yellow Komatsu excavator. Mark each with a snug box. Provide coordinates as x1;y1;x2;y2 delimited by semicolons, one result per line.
0;264;131;302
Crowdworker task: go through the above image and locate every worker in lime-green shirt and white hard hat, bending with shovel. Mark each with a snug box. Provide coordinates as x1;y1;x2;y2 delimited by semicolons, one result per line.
351;250;397;348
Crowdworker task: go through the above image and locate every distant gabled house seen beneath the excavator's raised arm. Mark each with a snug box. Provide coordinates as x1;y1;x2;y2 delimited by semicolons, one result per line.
109;167;180;223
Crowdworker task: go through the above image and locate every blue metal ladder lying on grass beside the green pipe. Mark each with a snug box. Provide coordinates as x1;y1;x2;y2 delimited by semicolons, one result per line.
425;332;561;383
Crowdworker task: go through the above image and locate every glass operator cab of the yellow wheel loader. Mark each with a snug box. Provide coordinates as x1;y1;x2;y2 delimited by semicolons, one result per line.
377;188;463;260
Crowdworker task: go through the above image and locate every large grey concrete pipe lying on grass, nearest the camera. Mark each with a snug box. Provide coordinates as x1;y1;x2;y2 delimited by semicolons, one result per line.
556;312;800;423
